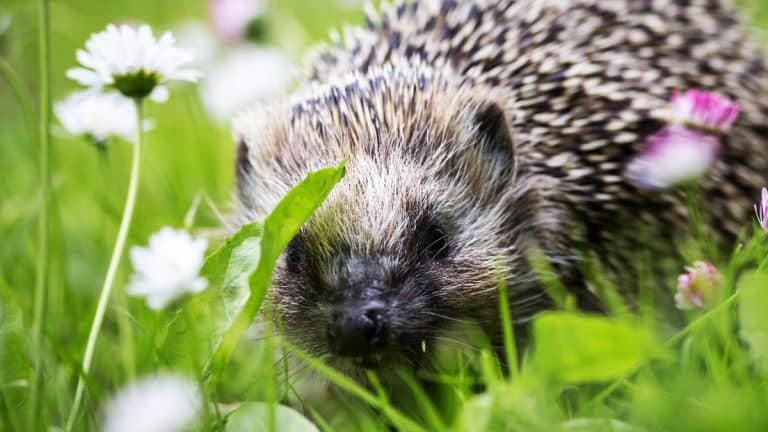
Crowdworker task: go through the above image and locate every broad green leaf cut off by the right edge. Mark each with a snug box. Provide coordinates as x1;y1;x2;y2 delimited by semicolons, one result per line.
739;272;768;372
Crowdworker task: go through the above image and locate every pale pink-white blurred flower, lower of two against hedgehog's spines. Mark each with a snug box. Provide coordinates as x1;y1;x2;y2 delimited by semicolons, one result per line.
627;125;720;190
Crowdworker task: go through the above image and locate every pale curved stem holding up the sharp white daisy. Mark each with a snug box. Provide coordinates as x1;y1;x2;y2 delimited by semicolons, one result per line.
66;99;144;431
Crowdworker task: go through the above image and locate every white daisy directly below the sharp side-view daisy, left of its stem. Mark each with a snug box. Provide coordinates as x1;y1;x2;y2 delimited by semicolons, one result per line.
53;90;136;146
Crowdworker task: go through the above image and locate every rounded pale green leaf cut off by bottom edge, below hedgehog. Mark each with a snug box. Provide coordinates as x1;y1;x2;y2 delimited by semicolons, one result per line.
225;402;320;432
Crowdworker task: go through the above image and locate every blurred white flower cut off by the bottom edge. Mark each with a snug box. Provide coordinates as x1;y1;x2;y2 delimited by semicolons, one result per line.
104;374;203;432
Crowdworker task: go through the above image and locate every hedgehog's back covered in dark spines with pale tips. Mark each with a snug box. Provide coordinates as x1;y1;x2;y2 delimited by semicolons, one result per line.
309;0;768;256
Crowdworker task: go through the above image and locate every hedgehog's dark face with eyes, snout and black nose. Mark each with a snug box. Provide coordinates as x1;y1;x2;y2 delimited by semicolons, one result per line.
273;164;452;366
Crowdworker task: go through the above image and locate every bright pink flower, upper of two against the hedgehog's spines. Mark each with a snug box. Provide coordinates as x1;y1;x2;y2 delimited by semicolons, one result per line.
670;90;740;132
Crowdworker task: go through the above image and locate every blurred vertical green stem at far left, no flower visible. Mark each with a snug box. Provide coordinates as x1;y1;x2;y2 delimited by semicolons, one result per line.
29;0;51;429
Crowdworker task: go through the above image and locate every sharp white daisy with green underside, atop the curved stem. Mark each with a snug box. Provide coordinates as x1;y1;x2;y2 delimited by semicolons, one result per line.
67;24;200;102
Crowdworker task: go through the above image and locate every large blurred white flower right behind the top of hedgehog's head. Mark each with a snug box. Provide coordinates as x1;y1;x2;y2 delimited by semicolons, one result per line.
200;45;293;122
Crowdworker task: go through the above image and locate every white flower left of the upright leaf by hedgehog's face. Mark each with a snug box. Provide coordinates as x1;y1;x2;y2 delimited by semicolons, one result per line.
128;227;208;310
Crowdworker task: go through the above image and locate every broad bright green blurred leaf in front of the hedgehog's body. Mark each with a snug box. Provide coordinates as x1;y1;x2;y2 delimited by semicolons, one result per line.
533;312;658;383
